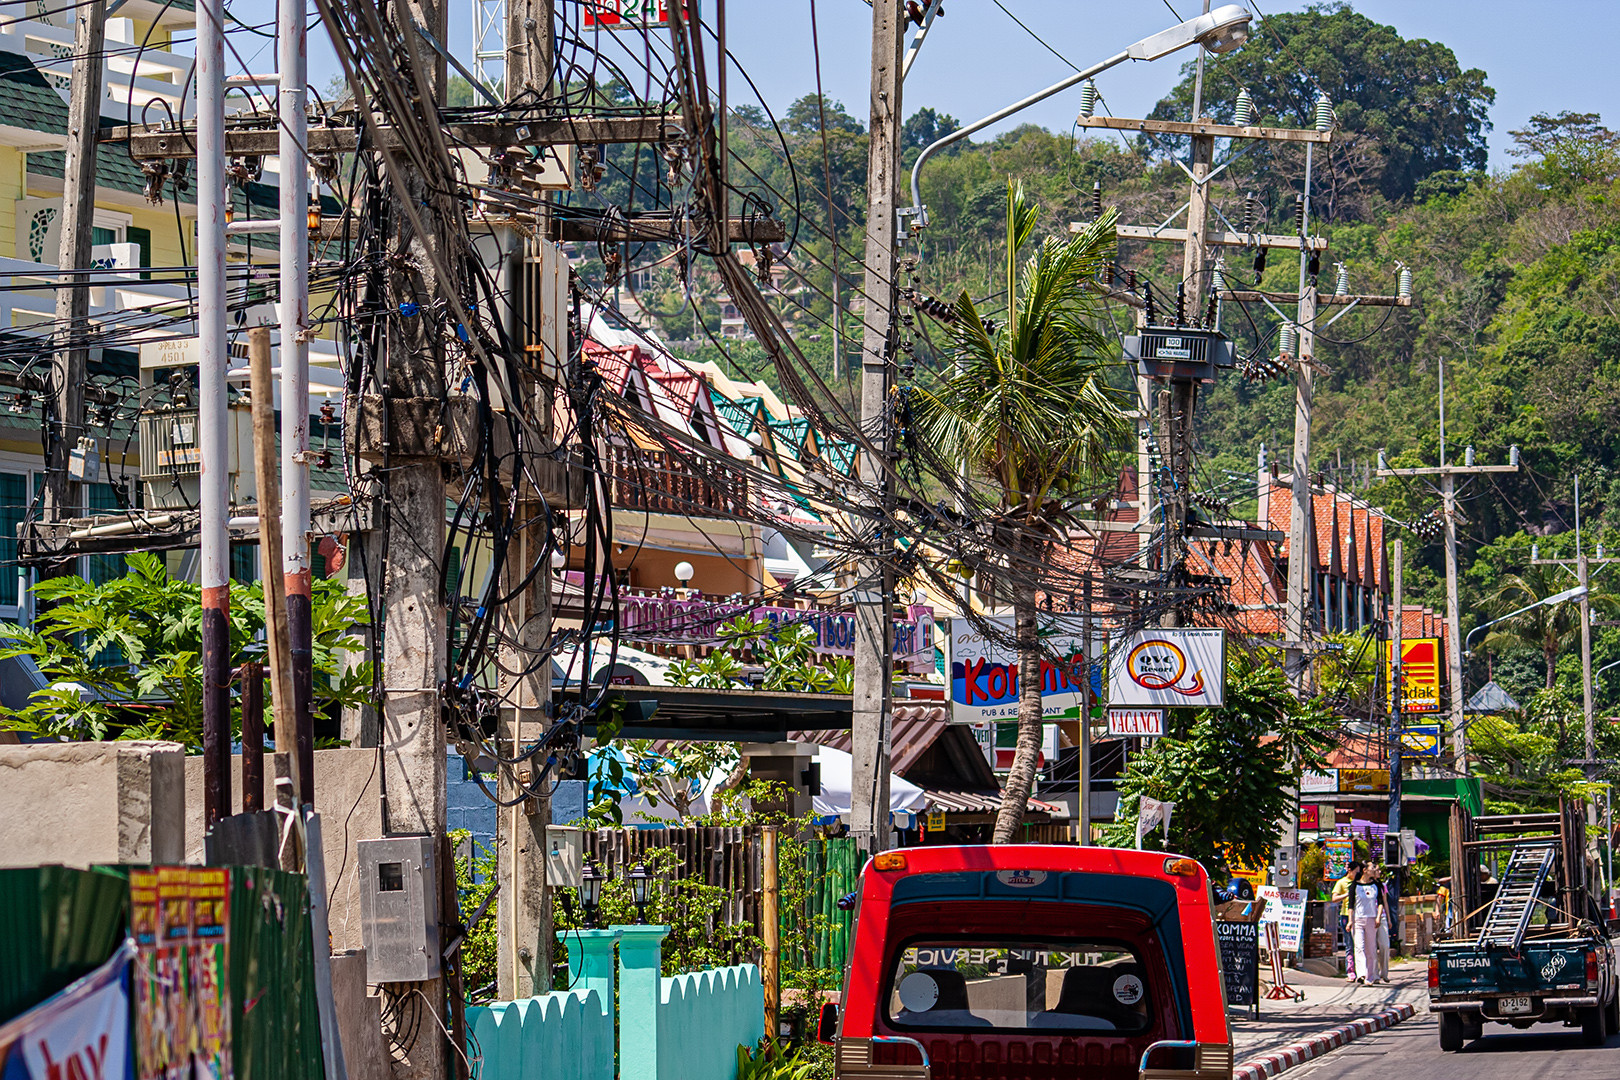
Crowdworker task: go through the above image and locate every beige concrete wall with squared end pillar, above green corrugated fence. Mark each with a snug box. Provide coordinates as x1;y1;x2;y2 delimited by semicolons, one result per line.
0;740;185;866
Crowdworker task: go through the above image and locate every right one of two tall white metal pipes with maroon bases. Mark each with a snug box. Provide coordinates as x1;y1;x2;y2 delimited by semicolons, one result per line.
275;0;314;805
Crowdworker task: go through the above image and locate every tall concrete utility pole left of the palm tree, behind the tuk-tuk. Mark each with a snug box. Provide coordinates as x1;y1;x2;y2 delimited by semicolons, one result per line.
849;0;906;852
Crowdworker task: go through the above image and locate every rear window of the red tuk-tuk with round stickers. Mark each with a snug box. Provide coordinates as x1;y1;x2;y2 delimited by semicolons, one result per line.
885;938;1153;1035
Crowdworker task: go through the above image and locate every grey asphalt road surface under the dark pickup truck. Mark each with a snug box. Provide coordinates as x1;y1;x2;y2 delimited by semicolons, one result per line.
1283;1015;1620;1080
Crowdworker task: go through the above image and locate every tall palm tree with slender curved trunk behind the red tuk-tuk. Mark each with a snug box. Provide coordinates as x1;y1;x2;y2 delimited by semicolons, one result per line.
917;183;1131;844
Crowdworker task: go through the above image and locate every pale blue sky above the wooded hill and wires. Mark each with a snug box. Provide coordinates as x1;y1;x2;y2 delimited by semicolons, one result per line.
272;0;1620;167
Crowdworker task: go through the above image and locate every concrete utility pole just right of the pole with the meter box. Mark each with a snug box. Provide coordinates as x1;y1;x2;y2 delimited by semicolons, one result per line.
496;0;567;1001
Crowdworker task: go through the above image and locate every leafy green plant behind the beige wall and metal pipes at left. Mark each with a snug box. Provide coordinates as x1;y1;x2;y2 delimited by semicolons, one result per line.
0;552;371;750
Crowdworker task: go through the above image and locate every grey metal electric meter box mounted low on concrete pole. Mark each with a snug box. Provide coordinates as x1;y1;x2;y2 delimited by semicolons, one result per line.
358;836;441;983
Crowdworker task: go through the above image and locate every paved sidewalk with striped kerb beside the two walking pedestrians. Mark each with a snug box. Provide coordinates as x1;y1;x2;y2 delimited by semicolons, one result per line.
1226;960;1429;1064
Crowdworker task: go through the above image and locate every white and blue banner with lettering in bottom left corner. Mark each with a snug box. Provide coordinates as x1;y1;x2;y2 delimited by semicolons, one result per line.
0;941;134;1080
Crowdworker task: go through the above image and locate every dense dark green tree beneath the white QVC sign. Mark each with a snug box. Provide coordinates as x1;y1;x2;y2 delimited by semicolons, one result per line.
1105;664;1338;871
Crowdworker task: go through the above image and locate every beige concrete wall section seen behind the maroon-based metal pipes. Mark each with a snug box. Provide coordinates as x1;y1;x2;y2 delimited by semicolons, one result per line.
185;746;382;952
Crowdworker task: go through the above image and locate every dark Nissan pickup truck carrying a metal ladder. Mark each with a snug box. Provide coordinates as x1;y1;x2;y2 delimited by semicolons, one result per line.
1429;801;1620;1051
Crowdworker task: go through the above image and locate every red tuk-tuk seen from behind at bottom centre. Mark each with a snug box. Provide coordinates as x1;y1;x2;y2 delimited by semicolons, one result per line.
820;844;1233;1080
